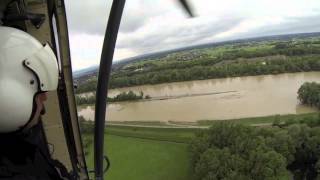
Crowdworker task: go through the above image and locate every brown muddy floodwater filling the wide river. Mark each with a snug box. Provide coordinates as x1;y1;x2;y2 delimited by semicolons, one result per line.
78;72;320;121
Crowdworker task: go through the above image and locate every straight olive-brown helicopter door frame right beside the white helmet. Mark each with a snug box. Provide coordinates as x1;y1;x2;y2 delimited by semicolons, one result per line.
47;0;89;179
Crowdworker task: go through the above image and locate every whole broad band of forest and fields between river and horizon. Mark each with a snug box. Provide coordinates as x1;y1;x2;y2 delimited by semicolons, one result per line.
77;39;320;93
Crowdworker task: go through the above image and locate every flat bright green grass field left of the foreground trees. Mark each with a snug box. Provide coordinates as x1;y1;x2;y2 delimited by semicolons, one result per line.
87;134;193;180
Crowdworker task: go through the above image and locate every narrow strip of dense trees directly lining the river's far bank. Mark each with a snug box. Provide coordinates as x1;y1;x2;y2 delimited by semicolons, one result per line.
108;56;320;89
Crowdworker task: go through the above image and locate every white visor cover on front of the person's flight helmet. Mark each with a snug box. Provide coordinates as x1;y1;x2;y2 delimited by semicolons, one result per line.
24;44;59;91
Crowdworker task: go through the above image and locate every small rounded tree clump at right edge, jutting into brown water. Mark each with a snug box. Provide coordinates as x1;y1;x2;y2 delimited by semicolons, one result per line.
298;82;320;108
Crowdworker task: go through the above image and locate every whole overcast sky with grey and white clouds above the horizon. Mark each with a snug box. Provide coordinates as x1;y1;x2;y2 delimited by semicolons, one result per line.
66;0;320;70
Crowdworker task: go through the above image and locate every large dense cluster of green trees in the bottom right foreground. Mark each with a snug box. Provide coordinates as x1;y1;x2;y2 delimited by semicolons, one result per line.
191;121;320;180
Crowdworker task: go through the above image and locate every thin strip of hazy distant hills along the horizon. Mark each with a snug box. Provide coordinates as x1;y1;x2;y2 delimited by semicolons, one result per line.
73;32;320;79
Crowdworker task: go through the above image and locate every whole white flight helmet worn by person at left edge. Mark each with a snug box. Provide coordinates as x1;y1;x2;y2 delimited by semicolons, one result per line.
0;26;59;133
